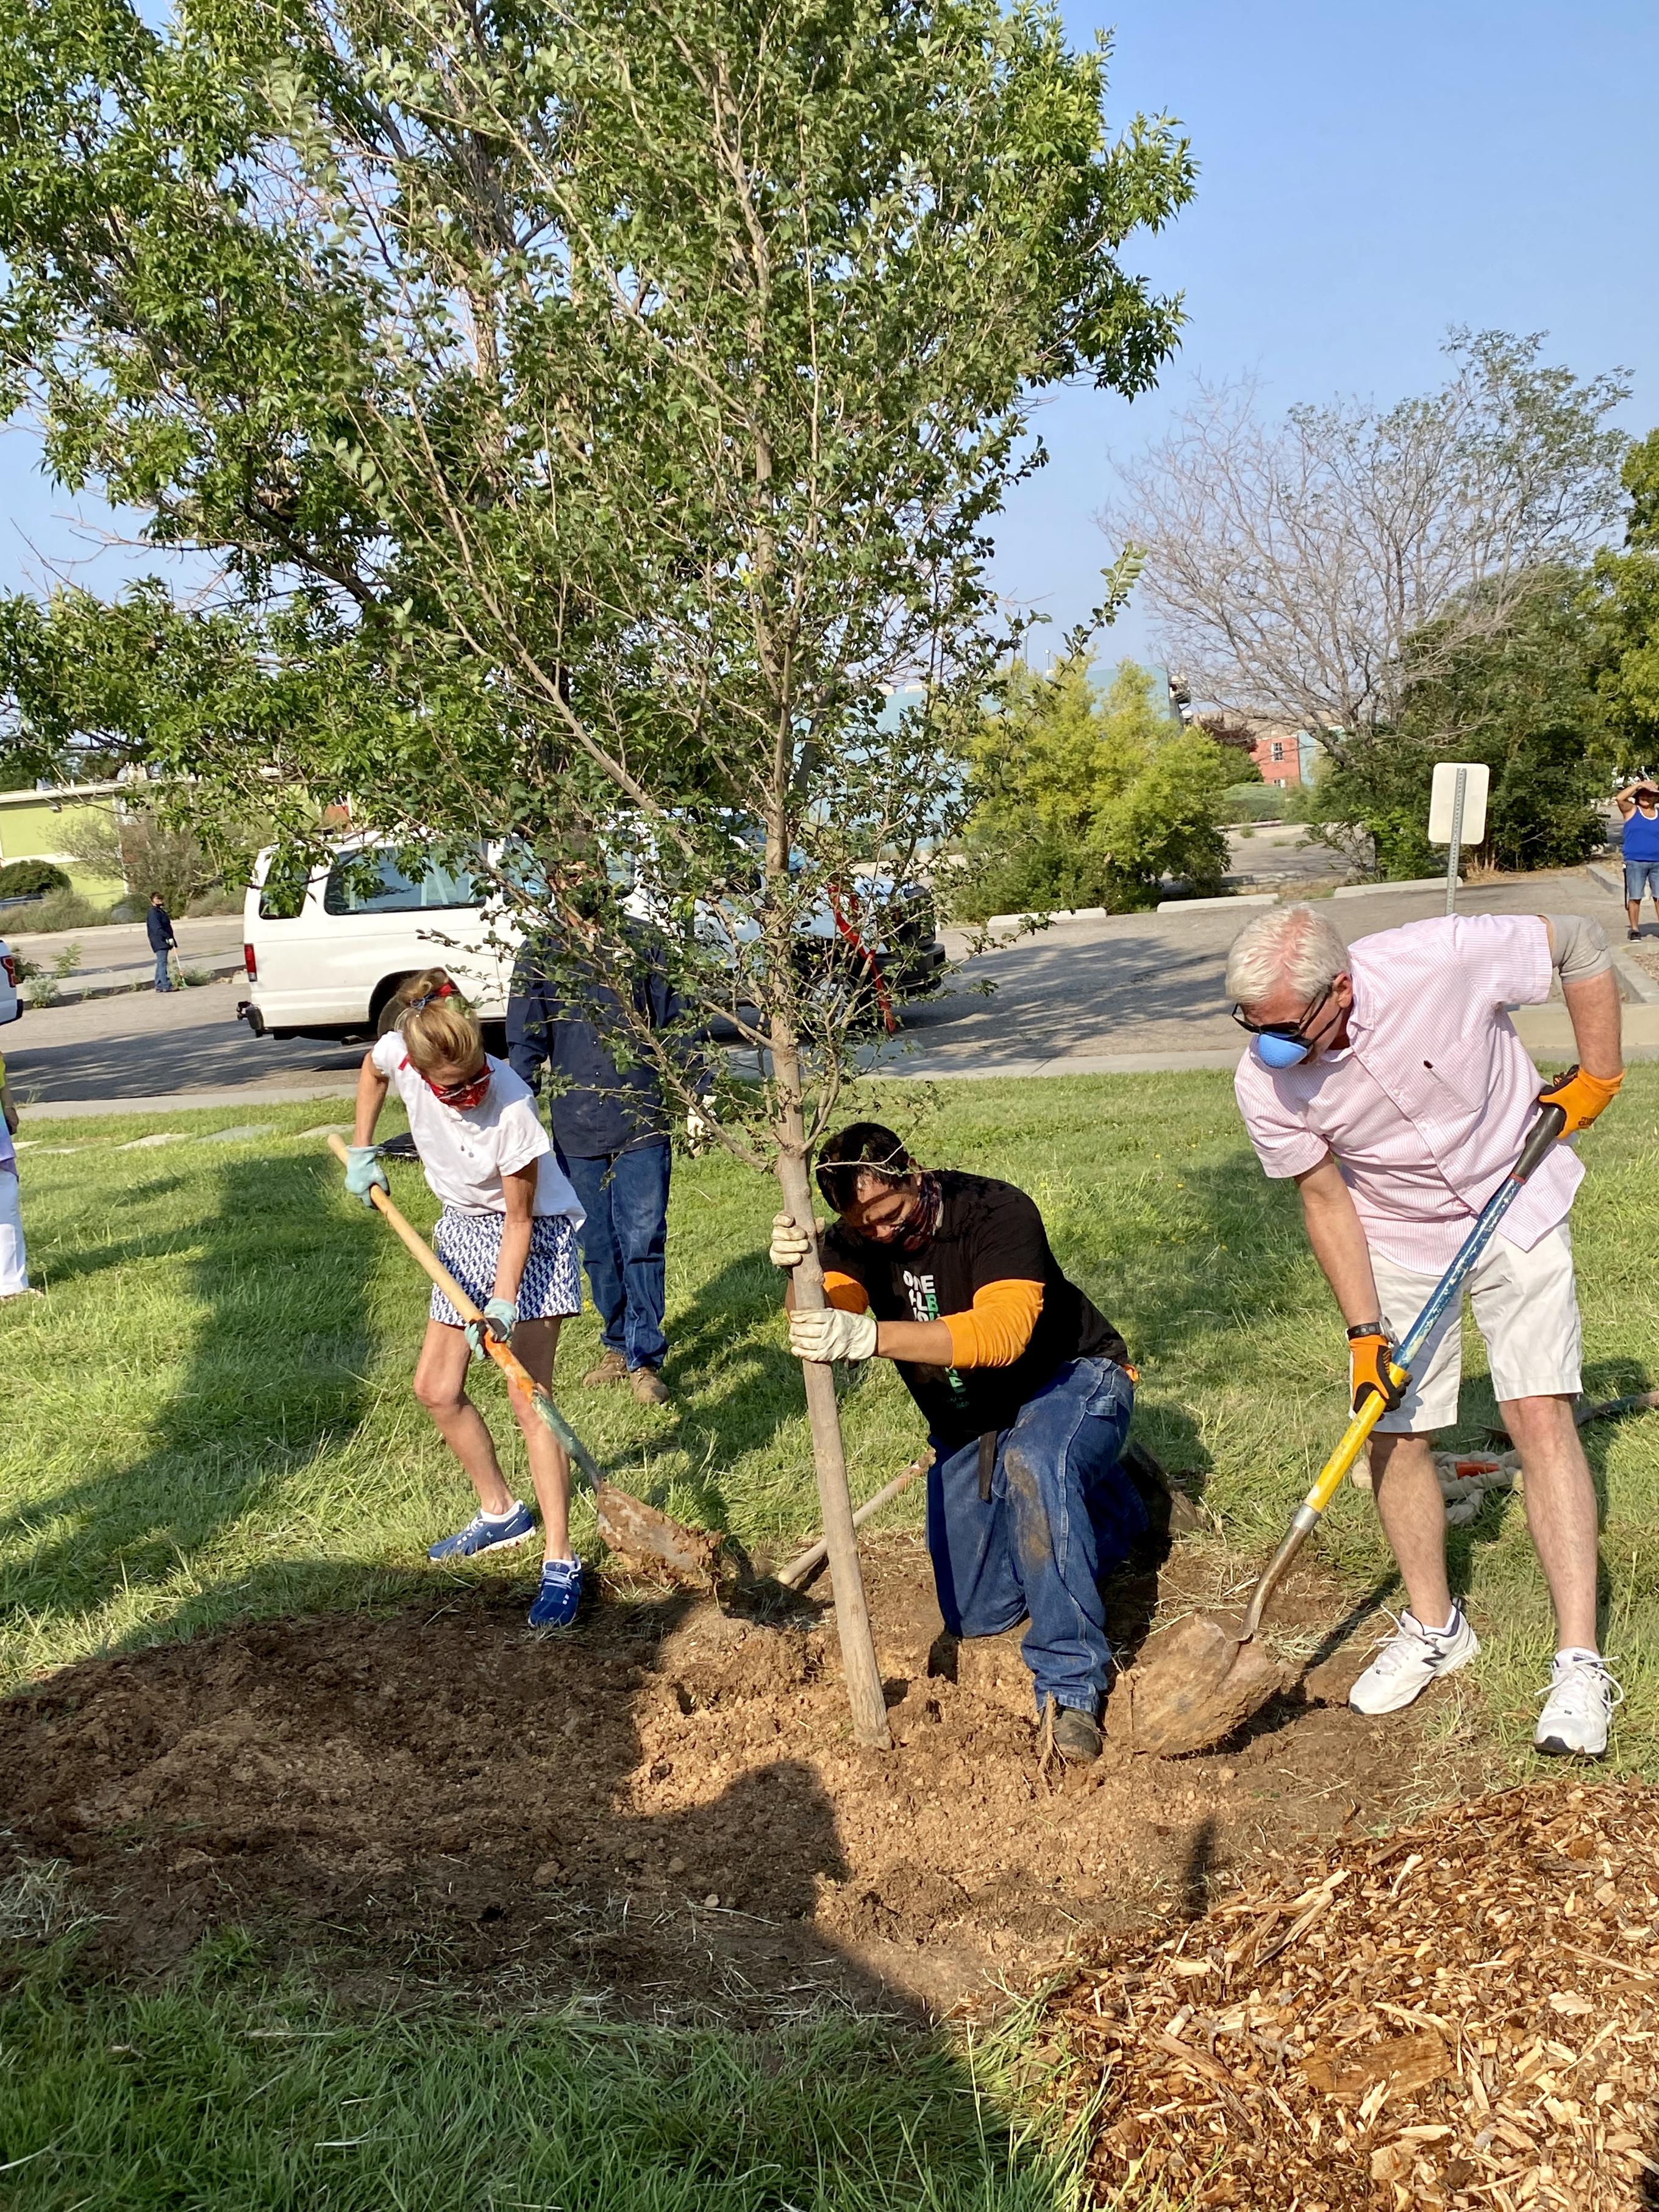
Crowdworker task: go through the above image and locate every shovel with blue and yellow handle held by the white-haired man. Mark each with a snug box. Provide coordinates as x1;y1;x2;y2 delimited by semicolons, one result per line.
1124;1106;1566;1754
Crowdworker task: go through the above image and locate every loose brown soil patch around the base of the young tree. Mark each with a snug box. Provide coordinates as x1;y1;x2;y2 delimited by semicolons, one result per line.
0;1537;1460;2024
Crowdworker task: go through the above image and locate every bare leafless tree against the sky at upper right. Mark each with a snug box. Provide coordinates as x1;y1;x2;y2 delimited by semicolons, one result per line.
1102;330;1630;758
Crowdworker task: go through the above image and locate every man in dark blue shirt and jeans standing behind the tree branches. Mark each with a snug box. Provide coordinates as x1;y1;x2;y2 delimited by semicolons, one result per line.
507;938;699;1405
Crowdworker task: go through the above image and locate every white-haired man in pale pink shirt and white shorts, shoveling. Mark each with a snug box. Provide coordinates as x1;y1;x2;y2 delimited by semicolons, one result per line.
1228;905;1624;1758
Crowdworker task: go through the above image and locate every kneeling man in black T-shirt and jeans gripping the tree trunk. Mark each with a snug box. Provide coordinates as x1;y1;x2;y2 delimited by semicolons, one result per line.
772;1121;1146;1761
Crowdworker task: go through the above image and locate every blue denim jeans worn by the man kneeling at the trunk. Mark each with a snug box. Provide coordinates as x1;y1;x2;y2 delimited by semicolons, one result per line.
927;1358;1146;1716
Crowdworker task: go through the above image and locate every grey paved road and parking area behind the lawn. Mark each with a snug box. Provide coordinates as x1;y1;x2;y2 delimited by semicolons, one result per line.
0;869;1659;1110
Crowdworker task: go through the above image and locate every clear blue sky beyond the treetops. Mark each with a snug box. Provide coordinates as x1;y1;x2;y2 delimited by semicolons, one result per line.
0;0;1659;657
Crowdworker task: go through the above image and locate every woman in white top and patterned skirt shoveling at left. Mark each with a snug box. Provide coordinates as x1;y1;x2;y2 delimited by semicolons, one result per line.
345;969;582;1628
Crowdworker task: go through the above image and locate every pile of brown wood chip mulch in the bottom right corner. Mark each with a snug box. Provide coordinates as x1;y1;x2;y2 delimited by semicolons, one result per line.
1046;1783;1659;2212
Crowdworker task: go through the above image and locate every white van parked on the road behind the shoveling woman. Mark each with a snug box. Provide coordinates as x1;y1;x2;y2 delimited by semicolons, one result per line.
237;838;520;1042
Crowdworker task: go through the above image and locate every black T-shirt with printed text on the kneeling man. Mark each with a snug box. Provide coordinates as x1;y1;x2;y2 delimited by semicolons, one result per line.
823;1170;1128;1451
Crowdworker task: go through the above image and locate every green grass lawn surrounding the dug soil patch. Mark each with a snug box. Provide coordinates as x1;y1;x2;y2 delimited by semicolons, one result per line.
0;1068;1659;2212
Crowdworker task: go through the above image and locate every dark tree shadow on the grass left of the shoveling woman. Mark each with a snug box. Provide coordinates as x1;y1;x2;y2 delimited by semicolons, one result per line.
0;1157;396;1663
